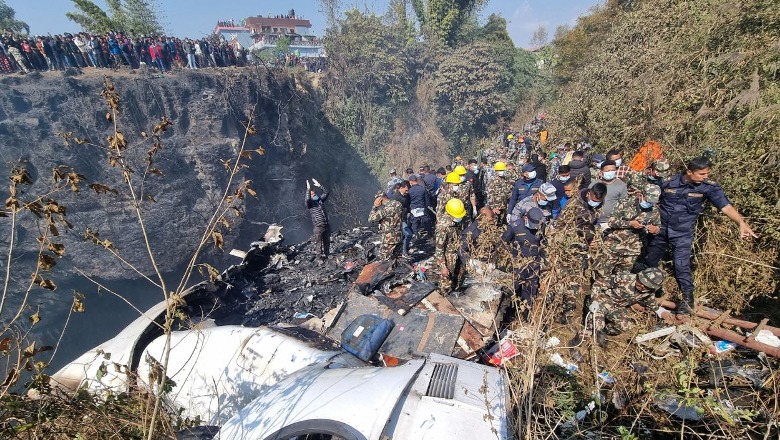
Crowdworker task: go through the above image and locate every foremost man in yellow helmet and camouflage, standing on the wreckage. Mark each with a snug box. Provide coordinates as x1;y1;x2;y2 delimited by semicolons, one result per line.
433;198;466;294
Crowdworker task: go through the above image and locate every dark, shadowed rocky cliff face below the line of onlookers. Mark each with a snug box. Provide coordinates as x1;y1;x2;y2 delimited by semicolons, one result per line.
0;69;379;279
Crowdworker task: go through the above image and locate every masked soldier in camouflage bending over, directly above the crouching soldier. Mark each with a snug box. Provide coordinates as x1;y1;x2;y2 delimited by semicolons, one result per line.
593;185;661;300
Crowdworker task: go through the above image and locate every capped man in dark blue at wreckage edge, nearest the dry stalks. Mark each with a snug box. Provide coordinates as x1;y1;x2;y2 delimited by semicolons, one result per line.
501;208;544;306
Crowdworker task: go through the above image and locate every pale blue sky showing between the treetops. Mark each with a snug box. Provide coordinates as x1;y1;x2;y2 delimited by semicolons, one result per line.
5;0;600;47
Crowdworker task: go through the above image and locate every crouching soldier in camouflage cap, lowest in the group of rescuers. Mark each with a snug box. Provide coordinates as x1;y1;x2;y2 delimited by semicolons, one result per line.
590;267;665;348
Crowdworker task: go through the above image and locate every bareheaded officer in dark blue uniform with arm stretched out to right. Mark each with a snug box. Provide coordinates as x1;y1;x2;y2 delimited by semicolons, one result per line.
644;157;756;314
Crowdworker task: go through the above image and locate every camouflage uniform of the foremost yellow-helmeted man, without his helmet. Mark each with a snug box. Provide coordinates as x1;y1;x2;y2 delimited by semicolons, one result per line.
433;212;466;293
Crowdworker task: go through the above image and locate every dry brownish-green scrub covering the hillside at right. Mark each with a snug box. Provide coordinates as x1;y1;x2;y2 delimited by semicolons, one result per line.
549;0;780;312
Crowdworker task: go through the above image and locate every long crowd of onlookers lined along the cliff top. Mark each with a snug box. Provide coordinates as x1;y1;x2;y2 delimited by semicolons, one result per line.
0;32;327;74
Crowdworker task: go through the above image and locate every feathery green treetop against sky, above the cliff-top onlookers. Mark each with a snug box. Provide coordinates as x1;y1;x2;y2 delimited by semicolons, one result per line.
65;0;163;35
